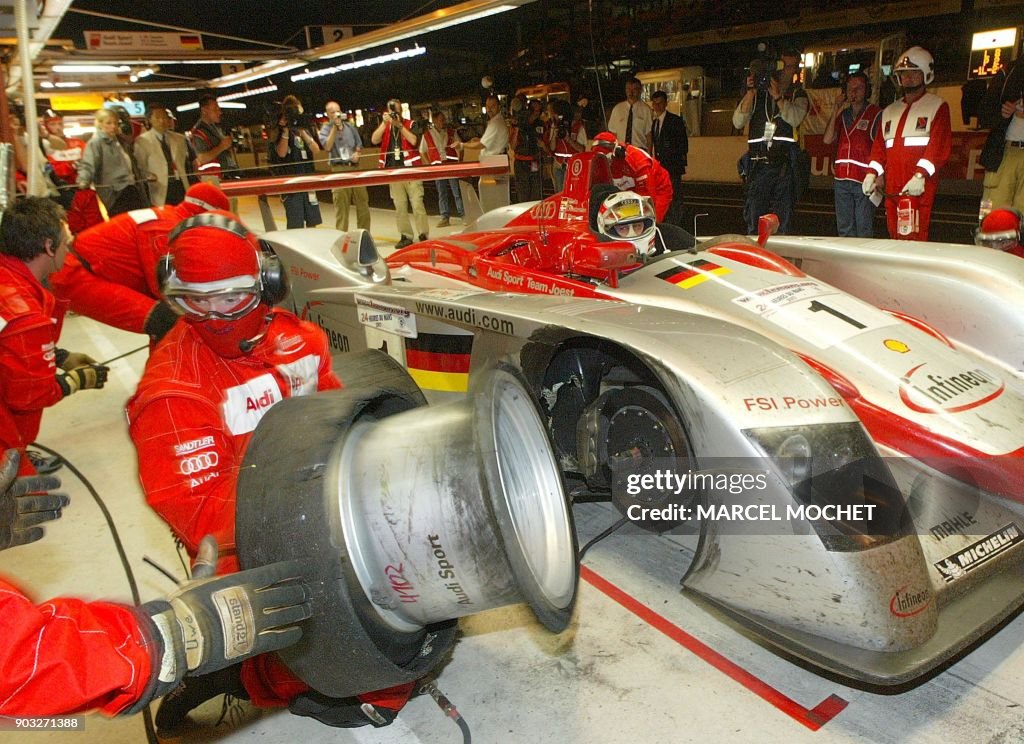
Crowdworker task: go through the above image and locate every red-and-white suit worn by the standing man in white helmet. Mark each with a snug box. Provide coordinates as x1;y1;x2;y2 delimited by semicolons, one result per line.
870;93;952;240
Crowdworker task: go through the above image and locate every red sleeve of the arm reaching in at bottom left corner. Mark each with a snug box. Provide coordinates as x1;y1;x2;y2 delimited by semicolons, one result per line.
0;579;160;716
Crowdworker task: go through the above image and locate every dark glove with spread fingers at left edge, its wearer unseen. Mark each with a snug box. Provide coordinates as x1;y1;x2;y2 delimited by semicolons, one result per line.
0;449;70;551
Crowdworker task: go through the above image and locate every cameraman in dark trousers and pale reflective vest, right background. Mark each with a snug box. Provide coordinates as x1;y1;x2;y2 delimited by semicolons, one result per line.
732;51;809;234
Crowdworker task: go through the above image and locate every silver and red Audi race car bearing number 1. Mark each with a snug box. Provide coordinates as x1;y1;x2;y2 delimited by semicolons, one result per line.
263;154;1024;685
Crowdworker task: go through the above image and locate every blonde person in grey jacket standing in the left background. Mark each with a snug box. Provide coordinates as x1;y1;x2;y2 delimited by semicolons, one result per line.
78;108;150;217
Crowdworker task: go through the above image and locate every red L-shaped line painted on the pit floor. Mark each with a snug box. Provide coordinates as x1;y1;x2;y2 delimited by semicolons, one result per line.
580;566;849;731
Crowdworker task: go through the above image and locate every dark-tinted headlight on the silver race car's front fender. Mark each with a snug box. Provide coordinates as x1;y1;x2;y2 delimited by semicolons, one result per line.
743;423;911;552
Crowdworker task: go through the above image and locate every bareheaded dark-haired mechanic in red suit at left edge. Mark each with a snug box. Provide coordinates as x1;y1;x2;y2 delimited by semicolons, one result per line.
0;196;108;475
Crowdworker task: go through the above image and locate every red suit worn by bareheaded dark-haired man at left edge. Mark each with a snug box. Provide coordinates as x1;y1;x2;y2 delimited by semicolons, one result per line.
0;255;67;475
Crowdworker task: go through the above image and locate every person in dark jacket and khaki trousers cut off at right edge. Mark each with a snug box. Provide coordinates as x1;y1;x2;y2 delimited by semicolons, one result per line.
979;59;1024;212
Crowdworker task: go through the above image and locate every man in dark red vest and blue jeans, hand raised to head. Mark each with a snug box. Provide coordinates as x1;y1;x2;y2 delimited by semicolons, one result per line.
822;72;882;237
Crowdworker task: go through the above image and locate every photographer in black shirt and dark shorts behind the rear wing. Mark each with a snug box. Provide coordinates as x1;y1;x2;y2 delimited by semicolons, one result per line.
268;95;324;230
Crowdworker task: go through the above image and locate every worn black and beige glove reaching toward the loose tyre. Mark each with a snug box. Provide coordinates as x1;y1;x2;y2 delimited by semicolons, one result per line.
140;538;312;702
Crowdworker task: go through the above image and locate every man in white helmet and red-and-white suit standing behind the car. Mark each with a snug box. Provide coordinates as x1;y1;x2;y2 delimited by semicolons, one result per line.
863;46;952;240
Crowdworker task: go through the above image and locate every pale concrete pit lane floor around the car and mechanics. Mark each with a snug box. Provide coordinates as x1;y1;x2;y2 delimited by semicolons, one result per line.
12;199;1024;744
